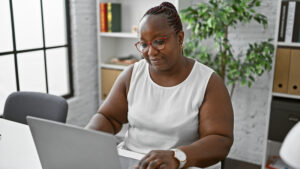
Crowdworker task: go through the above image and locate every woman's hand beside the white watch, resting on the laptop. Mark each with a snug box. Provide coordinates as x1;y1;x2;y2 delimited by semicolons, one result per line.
135;150;179;169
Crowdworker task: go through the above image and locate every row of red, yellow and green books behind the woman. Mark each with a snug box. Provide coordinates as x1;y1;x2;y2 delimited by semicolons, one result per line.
99;2;121;32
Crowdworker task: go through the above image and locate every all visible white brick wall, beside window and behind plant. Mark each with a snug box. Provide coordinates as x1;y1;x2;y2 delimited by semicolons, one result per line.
68;0;277;164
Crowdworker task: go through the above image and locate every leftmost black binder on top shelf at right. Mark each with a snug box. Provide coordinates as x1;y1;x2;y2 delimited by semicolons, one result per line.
278;1;289;41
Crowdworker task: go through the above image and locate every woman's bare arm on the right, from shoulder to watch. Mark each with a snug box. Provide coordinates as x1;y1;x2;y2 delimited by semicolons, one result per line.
179;73;233;168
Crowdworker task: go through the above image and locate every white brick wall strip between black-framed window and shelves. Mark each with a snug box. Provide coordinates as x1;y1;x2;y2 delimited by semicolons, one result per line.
67;0;98;126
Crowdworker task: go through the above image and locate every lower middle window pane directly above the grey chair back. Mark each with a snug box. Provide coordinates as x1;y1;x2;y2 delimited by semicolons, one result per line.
17;51;46;92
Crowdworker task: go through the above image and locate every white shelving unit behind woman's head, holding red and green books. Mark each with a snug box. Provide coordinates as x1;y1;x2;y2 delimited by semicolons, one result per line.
96;0;196;100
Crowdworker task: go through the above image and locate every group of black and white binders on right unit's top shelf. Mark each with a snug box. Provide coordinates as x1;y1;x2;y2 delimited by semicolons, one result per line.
278;1;300;43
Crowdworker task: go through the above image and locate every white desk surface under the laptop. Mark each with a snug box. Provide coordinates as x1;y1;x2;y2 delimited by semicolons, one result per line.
0;118;143;169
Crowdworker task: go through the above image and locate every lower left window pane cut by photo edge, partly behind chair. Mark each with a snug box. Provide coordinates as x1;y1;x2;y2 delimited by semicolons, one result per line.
0;55;17;114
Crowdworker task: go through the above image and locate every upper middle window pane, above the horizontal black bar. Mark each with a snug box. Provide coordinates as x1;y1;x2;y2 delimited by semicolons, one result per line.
13;0;43;50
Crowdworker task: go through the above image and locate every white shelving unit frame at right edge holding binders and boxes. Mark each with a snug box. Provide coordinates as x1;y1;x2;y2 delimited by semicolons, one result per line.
262;0;300;169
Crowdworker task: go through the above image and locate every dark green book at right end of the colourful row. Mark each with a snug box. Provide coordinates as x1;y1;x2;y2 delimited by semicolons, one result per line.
111;3;121;32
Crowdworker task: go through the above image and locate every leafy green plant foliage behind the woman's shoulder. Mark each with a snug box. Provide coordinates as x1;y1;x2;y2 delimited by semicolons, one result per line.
180;0;274;96
